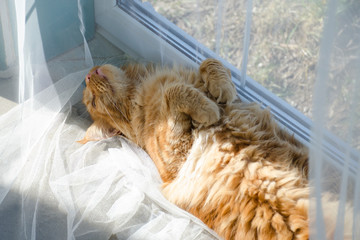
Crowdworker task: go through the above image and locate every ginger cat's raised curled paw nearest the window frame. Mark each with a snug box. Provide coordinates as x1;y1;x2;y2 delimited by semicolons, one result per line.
199;58;236;103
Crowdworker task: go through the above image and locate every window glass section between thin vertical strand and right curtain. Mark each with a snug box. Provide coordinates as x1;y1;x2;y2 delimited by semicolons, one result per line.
248;0;326;116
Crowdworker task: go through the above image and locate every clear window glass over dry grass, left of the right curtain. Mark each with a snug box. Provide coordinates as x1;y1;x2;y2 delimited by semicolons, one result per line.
146;0;326;116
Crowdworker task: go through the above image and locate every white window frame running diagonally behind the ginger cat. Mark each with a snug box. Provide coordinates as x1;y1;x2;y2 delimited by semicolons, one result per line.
94;0;360;175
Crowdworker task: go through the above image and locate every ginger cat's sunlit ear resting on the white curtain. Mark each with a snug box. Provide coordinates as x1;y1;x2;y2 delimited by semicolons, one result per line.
77;121;121;144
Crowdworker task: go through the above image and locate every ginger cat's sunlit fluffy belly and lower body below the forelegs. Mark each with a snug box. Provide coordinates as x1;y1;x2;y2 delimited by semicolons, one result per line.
163;132;309;239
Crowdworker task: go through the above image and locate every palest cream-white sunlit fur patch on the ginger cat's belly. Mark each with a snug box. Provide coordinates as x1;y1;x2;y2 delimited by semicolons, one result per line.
163;133;231;212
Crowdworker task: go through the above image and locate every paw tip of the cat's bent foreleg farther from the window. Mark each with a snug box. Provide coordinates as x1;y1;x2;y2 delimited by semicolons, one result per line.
191;101;220;127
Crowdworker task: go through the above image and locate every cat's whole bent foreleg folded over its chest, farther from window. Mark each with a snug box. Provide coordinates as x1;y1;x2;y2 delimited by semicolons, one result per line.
164;84;220;126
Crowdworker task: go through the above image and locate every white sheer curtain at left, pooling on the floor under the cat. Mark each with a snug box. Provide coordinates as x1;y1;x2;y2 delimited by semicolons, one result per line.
0;0;216;240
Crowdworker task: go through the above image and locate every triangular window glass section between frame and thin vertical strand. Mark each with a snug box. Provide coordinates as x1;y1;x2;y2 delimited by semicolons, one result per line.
149;0;246;64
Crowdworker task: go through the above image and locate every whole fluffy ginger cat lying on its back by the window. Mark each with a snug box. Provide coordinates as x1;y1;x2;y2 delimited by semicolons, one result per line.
80;59;309;239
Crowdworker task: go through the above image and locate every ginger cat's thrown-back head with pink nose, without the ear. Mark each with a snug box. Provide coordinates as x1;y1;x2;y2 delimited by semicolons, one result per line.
83;64;127;123
